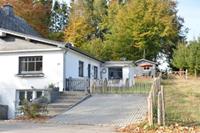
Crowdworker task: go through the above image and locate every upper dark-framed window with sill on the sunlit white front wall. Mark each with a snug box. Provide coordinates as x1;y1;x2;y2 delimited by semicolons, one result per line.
19;56;42;74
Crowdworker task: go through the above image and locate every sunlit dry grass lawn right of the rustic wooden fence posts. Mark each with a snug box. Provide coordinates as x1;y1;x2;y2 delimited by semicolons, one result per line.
162;79;200;126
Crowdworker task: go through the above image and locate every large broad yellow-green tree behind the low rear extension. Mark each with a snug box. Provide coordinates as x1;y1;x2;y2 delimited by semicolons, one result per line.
103;0;185;60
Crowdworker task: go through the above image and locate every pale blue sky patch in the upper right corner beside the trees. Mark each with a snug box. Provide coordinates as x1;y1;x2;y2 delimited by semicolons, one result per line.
177;0;200;40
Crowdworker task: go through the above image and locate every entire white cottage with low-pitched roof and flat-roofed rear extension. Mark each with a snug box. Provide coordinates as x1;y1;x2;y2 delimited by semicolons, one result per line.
0;28;134;118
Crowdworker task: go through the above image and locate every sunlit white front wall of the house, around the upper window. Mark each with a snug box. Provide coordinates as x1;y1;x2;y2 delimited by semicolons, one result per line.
0;51;64;118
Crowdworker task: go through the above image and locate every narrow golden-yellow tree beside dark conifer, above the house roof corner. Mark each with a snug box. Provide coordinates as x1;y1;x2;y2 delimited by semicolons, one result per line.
64;0;94;47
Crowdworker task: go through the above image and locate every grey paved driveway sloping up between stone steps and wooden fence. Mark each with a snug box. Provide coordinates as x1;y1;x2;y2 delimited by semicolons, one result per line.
49;95;147;127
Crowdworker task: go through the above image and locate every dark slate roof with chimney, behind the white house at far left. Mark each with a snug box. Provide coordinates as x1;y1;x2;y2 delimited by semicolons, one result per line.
0;5;40;36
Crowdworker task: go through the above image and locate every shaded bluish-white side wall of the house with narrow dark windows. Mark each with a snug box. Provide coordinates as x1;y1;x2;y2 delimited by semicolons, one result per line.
65;50;101;79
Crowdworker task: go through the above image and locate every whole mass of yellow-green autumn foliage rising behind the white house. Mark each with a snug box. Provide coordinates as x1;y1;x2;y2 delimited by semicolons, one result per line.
65;0;183;60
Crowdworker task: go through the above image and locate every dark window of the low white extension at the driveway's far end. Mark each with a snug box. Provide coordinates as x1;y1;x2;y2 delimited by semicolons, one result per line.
108;67;123;79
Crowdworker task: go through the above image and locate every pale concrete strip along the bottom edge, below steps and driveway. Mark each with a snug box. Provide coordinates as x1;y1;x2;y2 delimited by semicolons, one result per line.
0;121;116;133
